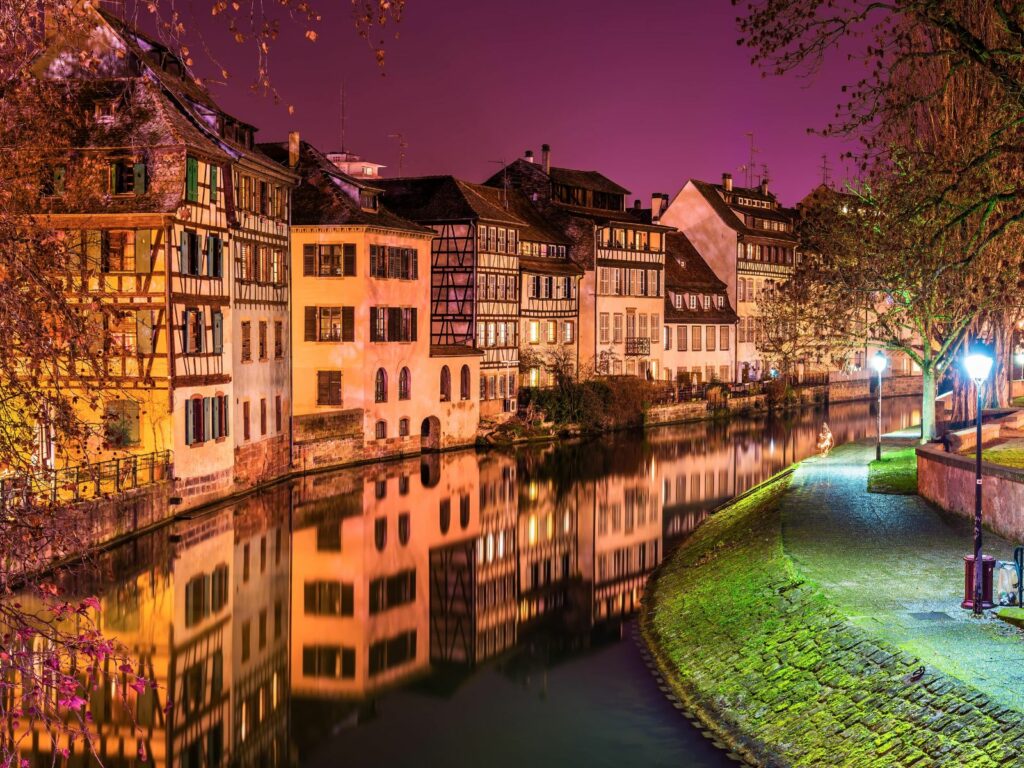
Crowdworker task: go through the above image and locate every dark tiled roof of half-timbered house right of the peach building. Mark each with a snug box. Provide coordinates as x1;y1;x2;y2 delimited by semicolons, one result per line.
374;176;525;226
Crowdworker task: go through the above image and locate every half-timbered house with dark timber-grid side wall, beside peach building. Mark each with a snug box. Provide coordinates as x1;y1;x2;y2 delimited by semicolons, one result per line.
376;176;525;419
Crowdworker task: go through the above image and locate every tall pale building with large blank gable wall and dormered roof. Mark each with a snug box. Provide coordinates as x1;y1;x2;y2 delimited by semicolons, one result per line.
652;173;798;381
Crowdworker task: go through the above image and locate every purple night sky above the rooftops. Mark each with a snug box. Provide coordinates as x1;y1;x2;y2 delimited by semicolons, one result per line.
195;0;857;206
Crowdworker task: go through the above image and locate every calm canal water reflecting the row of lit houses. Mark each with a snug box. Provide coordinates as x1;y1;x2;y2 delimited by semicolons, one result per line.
37;398;920;768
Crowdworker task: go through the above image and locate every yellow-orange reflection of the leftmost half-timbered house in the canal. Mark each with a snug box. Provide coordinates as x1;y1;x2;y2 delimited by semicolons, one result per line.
14;486;290;768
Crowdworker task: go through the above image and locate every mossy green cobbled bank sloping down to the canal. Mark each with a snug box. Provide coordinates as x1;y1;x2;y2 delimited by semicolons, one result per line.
638;465;1024;766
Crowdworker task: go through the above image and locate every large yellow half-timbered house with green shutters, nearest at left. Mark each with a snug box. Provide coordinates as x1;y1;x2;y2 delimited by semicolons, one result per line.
27;8;291;506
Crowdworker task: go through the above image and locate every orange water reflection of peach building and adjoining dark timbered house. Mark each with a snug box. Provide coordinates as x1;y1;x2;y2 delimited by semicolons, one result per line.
291;453;515;697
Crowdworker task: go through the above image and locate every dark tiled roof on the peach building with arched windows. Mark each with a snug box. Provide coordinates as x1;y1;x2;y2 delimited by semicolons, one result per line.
259;141;433;234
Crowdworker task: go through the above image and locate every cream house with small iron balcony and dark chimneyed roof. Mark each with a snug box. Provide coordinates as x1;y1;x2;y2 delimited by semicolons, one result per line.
484;144;668;379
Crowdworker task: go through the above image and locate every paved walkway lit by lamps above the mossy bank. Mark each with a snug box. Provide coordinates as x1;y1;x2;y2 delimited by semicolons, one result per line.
780;442;1024;712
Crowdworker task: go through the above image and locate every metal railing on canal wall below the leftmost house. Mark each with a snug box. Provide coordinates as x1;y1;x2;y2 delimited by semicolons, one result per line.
0;451;172;511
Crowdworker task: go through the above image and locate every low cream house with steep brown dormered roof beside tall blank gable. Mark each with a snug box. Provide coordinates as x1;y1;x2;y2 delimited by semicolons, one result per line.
663;232;736;385
